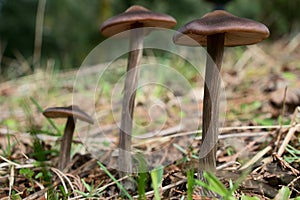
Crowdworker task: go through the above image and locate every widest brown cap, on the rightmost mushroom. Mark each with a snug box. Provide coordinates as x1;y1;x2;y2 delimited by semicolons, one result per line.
173;10;270;46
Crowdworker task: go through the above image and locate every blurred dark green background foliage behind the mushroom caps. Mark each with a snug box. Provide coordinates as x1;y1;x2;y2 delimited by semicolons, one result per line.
0;0;300;81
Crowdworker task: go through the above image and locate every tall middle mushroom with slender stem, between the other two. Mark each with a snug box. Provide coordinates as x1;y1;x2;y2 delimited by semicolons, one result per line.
100;5;176;183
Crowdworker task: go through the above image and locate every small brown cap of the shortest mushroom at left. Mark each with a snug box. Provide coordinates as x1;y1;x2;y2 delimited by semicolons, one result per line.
43;105;94;124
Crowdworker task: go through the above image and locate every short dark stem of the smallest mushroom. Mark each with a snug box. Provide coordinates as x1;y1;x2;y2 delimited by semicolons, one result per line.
58;117;76;170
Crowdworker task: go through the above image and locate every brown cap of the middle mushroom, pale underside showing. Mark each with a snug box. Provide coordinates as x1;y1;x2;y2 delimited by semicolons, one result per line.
100;5;176;37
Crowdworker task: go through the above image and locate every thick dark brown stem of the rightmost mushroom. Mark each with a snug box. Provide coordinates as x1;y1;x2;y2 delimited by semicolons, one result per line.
198;33;224;179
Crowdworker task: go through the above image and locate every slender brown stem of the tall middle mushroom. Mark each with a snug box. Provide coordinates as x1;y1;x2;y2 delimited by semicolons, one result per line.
119;26;144;180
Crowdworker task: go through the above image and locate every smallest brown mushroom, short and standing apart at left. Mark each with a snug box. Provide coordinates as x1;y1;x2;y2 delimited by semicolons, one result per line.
43;105;94;170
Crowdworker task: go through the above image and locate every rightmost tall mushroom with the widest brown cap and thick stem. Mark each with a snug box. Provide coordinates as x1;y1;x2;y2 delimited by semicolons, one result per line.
173;10;269;179
